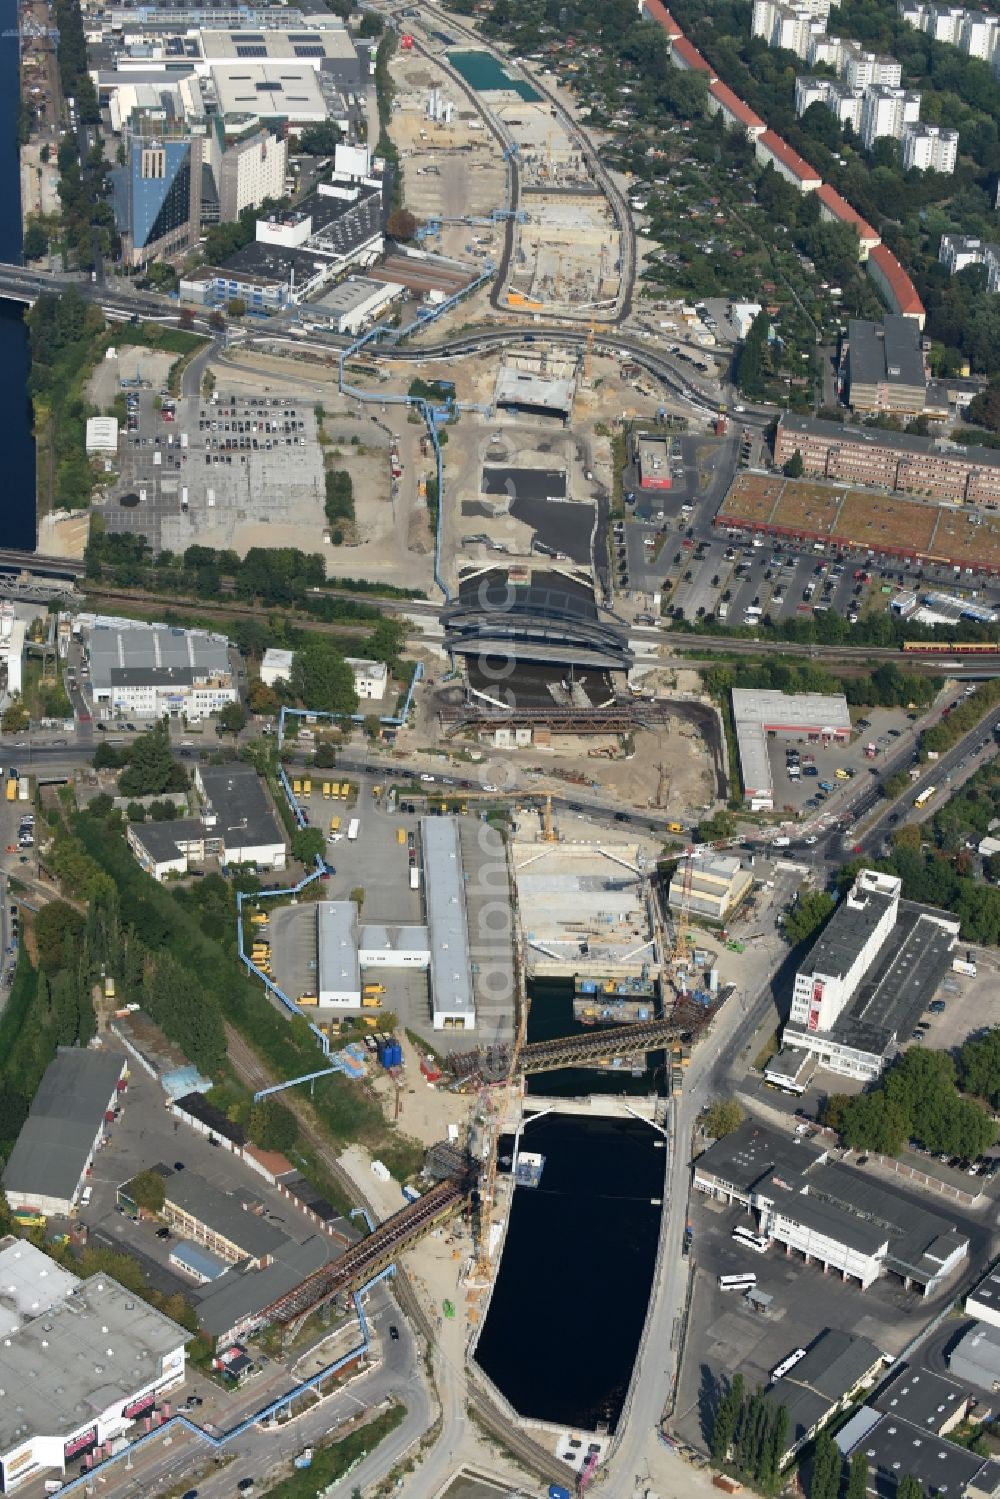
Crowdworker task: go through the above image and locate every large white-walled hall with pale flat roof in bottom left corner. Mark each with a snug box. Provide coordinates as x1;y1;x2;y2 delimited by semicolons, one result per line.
0;1256;190;1493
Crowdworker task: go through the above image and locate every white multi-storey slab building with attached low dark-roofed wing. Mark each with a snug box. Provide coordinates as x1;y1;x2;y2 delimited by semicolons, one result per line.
765;869;960;1091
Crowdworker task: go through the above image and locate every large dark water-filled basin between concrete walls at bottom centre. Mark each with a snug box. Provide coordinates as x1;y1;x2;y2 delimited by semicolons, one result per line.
475;1114;666;1432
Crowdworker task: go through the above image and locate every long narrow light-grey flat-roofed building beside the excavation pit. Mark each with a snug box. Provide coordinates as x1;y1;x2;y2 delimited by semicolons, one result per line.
420;817;475;1031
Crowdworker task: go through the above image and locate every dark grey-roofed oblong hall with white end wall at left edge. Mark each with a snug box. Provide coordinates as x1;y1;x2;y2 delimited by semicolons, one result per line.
1;1046;127;1217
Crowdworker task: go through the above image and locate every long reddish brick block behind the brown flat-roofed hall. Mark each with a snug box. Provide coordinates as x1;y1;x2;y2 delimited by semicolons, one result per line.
775;412;1000;505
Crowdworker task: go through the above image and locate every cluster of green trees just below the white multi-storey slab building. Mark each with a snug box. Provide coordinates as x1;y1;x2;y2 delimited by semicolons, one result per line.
823;1046;997;1160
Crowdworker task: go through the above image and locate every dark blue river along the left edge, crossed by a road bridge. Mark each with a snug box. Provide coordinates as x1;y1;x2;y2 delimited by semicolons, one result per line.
0;0;34;550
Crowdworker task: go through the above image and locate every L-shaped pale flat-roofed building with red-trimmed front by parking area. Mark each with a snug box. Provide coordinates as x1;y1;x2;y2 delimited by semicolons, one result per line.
732;687;850;812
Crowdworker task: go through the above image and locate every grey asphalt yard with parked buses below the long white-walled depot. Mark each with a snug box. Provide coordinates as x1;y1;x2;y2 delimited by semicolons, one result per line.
675;1187;988;1448
